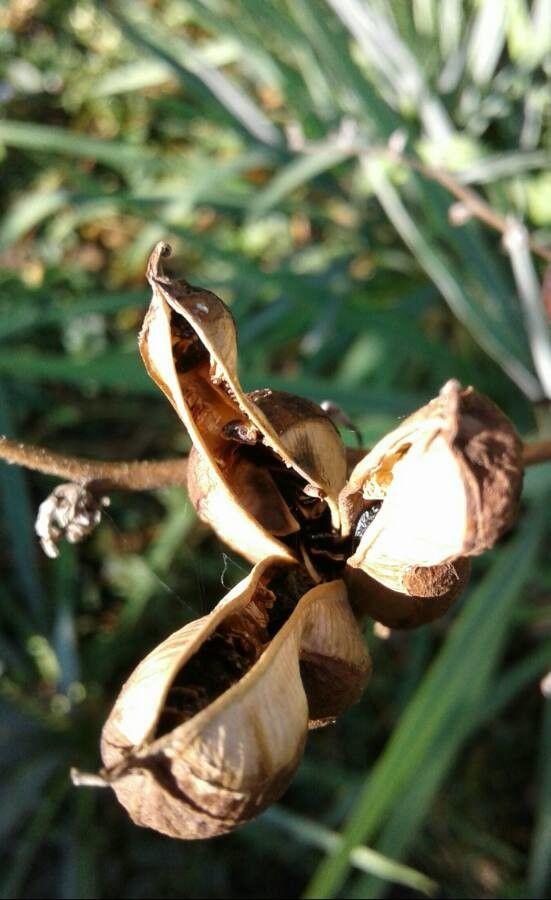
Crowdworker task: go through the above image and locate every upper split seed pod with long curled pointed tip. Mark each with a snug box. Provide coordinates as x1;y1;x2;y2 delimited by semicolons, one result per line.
140;244;347;561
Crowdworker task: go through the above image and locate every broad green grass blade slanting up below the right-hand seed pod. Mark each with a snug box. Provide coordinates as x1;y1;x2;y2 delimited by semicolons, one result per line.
306;504;546;900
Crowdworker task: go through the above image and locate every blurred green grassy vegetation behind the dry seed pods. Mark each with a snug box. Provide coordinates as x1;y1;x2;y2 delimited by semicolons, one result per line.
0;0;551;898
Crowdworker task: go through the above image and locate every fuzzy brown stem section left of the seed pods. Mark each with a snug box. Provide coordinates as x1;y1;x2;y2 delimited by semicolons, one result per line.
0;437;187;492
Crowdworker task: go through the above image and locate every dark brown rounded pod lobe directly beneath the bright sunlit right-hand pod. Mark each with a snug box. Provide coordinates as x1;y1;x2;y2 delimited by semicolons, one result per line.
344;558;471;628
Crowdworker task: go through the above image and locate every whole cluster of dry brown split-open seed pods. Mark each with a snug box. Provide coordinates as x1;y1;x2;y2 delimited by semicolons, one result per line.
77;244;522;838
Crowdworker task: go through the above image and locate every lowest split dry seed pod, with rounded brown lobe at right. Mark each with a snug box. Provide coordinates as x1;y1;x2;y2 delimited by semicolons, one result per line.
102;557;369;838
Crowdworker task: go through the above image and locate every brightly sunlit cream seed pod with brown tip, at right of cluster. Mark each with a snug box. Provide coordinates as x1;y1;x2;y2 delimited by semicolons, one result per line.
341;381;523;593
